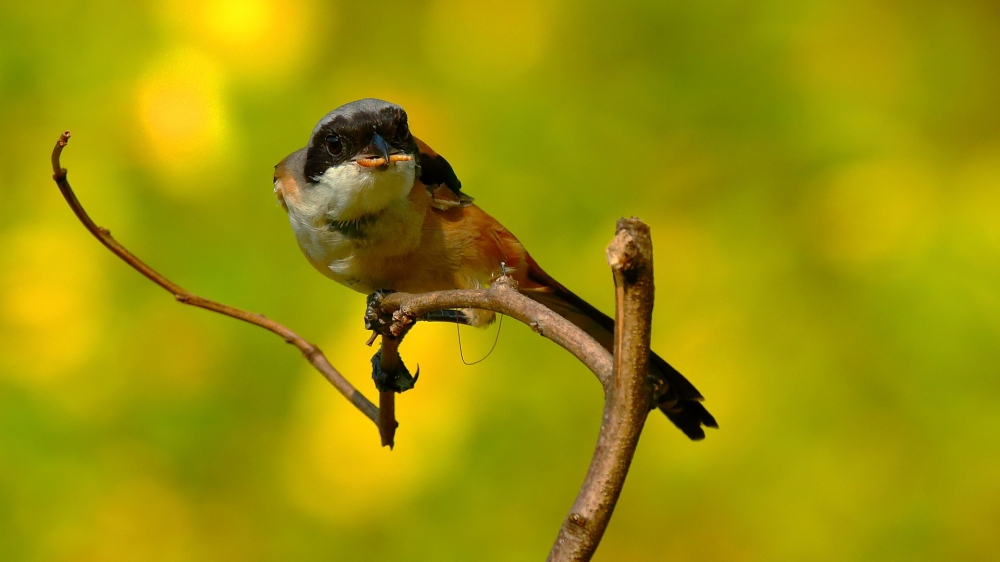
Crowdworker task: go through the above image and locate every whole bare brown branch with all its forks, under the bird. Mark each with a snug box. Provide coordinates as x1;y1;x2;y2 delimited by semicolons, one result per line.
52;131;668;562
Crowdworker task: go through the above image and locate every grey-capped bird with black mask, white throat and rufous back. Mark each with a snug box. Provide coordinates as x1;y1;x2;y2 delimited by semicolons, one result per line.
274;98;718;440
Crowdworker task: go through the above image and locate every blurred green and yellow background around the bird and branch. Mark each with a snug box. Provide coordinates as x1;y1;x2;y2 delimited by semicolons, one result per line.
0;0;1000;561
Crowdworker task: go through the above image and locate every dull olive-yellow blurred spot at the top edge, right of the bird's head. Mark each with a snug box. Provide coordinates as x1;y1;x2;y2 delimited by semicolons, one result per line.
423;0;552;82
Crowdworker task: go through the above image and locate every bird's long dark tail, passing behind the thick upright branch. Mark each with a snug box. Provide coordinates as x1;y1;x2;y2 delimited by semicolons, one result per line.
518;255;719;440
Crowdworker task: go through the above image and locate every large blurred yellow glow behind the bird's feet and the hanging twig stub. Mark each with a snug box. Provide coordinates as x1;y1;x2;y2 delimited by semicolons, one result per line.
286;298;471;525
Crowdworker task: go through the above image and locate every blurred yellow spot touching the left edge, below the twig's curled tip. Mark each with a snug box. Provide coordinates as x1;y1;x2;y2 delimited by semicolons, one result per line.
0;225;101;384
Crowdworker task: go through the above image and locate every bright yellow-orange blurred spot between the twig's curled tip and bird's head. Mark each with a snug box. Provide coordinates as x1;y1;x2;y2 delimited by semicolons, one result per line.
137;50;226;185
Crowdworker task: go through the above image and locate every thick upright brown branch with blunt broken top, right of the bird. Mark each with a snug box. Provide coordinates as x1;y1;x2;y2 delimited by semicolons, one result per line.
548;219;653;562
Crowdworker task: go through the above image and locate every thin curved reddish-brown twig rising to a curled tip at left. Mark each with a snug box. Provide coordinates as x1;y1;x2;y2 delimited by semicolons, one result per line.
52;131;379;424
